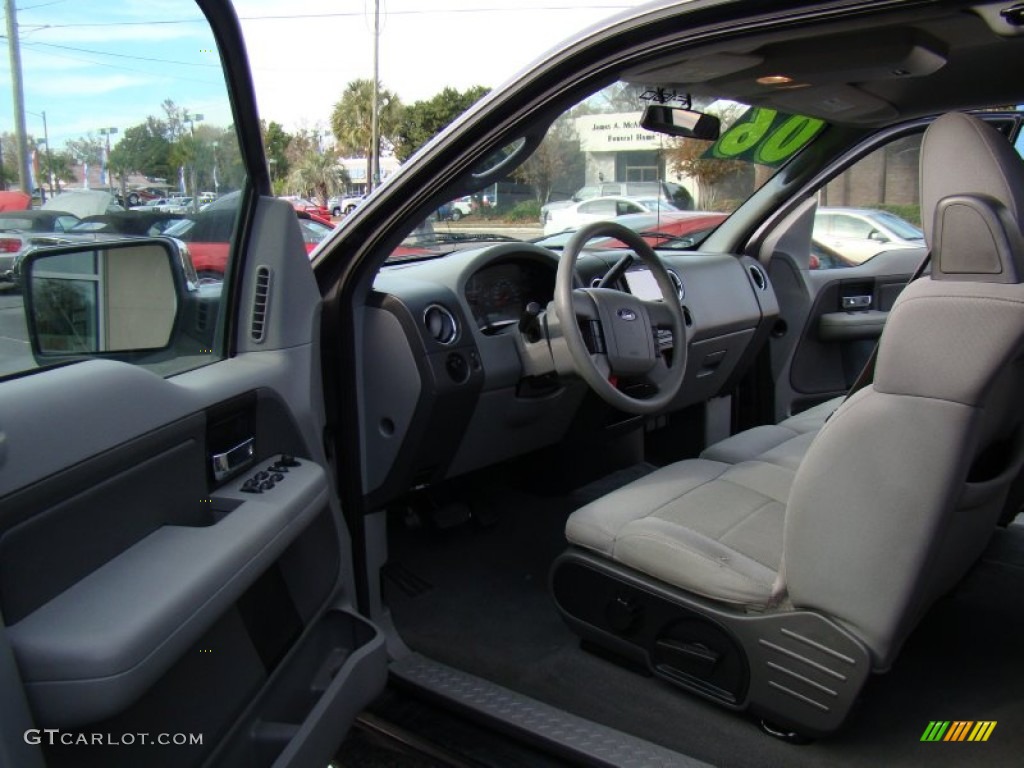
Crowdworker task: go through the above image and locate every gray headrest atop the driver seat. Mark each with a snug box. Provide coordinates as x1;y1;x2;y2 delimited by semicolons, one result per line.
921;113;1024;283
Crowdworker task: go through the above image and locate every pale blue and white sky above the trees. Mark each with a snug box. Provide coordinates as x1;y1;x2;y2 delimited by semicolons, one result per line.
0;0;640;148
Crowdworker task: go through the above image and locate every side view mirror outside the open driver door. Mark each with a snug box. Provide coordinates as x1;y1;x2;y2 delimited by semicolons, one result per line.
19;239;195;364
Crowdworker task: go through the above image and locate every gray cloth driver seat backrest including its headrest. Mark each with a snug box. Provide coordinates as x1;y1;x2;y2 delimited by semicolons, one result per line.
784;114;1024;669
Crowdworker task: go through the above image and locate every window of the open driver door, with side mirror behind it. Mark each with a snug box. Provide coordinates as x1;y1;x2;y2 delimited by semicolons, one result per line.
0;0;247;378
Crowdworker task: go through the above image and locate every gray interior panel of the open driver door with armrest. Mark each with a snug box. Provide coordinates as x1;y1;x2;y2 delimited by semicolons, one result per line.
0;202;386;766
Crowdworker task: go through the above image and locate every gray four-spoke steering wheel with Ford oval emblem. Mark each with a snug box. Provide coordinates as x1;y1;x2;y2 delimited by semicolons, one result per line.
554;221;686;414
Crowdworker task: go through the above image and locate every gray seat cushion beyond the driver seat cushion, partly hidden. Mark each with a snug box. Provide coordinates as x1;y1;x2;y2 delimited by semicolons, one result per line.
700;396;845;469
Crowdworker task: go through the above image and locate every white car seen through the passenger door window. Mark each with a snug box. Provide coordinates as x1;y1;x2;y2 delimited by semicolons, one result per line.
814;208;925;264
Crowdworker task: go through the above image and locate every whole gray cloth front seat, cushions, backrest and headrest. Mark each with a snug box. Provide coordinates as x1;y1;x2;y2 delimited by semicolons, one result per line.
566;114;1024;669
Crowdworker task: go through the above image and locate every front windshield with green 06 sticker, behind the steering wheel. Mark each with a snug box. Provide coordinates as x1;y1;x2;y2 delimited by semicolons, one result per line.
390;83;823;261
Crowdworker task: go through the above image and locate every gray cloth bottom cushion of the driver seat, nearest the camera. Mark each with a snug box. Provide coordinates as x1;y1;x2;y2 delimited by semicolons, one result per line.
565;459;795;606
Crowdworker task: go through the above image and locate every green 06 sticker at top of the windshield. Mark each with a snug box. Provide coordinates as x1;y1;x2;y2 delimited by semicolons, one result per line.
703;106;825;166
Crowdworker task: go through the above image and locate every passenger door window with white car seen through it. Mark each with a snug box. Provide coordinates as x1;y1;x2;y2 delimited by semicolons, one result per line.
811;133;924;269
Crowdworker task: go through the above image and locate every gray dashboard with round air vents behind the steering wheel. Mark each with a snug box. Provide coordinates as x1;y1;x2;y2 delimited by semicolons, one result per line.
360;242;778;504
